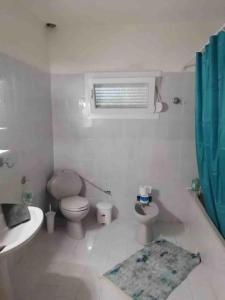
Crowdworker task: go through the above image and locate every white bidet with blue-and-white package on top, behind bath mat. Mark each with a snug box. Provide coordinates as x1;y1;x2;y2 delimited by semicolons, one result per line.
135;202;159;245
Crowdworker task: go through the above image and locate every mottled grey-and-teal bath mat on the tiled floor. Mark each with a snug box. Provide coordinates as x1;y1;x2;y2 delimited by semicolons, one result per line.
104;240;201;300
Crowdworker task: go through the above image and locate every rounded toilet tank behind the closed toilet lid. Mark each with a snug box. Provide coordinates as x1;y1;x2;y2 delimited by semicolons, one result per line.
47;170;82;200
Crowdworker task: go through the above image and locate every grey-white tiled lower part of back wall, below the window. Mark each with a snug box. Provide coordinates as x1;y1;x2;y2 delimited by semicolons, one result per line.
52;73;196;220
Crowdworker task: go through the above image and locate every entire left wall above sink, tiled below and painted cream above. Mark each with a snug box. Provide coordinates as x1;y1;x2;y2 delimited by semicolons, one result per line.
0;0;53;207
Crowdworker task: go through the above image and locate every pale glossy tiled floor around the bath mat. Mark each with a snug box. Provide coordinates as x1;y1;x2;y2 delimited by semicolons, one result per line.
12;219;225;300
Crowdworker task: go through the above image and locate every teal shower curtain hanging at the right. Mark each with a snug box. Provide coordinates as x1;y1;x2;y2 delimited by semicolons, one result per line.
195;31;225;237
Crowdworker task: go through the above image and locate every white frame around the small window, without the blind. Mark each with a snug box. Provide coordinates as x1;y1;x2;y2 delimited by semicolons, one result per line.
85;71;161;119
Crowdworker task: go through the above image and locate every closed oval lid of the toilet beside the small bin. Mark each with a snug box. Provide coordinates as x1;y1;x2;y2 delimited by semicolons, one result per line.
61;196;89;211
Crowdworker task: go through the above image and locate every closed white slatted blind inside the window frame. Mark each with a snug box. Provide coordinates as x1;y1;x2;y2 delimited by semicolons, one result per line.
93;83;149;108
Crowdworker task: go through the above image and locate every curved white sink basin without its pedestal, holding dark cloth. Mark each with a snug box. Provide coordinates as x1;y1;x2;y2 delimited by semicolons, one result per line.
0;206;43;257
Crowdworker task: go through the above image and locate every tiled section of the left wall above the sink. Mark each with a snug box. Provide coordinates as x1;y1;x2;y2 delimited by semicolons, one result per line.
0;54;53;208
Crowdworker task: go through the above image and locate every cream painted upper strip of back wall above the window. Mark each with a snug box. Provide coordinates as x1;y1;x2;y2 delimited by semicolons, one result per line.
49;20;222;74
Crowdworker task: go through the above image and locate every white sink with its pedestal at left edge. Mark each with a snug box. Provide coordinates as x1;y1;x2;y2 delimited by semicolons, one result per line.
0;206;44;300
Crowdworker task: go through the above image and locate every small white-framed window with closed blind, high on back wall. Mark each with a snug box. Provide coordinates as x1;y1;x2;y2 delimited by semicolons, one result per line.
85;72;161;119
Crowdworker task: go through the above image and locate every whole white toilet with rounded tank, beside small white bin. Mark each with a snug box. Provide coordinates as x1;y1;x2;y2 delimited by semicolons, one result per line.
47;170;89;240
